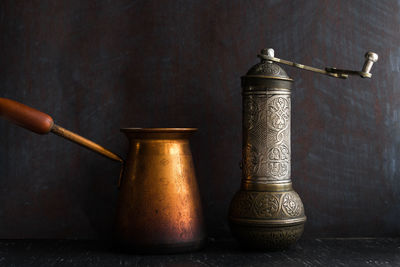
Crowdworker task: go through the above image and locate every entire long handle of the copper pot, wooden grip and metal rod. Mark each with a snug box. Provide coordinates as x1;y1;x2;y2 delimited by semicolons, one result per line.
0;97;124;163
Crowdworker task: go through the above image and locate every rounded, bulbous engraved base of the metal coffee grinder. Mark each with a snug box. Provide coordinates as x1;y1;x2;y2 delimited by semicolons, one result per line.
229;185;306;250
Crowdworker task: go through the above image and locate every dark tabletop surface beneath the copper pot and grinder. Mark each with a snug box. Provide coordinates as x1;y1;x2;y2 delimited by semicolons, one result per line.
0;238;400;267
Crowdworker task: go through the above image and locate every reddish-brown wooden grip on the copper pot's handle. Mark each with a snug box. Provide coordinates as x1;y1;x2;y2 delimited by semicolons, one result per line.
0;97;54;134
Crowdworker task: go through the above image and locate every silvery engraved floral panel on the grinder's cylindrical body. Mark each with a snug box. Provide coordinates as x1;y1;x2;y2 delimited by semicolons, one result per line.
243;93;290;183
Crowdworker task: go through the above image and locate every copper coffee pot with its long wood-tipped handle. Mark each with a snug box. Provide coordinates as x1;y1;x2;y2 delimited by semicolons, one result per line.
0;98;205;253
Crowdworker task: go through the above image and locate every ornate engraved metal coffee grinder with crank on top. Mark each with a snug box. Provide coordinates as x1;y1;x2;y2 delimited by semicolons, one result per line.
229;48;378;250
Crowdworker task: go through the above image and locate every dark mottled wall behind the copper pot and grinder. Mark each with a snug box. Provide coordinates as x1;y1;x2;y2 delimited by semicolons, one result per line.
0;0;400;239
